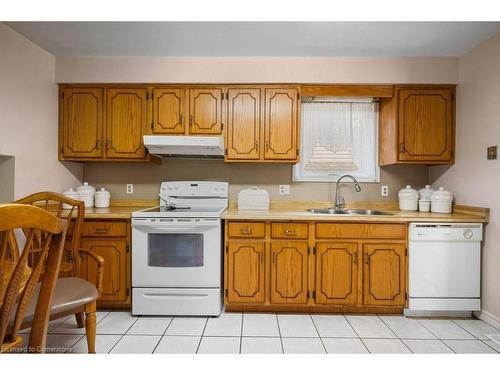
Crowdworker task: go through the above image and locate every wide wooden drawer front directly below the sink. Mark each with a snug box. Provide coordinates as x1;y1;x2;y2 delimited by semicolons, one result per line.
316;223;406;240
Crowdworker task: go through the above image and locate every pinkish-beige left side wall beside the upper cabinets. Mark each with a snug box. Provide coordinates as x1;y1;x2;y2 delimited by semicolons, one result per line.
0;23;83;198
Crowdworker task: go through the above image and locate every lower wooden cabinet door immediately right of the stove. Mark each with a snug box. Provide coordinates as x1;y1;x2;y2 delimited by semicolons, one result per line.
226;241;265;303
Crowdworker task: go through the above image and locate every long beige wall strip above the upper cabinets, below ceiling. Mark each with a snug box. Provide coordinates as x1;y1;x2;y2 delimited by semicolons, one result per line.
56;57;458;83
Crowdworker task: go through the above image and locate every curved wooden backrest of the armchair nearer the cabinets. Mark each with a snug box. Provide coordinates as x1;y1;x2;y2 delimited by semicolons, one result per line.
14;191;85;276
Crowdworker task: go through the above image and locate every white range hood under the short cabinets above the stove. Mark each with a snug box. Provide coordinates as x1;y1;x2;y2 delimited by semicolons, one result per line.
144;135;224;159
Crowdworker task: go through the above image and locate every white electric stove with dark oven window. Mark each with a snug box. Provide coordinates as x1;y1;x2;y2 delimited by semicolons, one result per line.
132;181;229;316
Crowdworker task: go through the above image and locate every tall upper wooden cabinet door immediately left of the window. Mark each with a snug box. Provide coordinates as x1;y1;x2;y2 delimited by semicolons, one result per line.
264;88;298;160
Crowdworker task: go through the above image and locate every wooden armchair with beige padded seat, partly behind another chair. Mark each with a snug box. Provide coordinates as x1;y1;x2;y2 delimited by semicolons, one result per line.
16;192;104;353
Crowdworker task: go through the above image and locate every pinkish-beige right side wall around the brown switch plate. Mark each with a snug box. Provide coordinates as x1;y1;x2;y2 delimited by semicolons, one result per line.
430;34;500;323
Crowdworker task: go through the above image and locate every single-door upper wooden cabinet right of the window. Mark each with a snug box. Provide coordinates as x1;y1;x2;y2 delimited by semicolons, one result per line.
379;86;455;165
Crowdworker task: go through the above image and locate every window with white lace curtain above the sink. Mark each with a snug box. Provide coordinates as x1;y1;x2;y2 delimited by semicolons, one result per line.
293;97;380;182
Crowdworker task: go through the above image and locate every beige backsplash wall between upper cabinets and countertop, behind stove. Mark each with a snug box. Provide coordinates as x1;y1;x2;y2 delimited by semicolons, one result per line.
84;159;428;201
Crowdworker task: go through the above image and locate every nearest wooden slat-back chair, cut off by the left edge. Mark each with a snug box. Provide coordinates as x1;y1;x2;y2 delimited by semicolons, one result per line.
0;204;66;353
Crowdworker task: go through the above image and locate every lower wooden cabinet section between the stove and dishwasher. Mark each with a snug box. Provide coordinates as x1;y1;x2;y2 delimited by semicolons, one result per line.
224;221;407;313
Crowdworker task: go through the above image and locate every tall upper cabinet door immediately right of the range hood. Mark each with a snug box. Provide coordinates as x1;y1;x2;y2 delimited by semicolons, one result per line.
226;88;261;160
